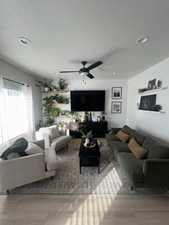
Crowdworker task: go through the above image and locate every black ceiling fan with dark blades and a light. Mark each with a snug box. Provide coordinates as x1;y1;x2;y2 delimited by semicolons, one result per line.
60;61;103;79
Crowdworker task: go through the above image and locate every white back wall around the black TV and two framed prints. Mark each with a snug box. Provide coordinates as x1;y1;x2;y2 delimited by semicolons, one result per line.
69;79;127;127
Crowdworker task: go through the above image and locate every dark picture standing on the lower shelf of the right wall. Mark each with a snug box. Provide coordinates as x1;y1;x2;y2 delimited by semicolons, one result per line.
139;95;156;111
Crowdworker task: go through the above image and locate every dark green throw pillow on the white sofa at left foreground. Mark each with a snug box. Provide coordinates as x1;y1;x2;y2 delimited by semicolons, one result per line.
1;138;28;160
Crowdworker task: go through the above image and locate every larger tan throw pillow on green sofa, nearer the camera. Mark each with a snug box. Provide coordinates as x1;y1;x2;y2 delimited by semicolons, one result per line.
128;138;147;159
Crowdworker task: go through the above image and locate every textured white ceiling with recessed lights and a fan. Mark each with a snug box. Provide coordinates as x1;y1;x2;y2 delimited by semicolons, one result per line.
0;0;169;79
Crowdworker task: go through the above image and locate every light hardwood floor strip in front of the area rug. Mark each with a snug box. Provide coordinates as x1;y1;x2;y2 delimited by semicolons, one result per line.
0;195;169;225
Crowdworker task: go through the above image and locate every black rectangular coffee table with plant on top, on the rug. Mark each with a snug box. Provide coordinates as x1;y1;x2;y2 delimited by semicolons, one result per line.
79;139;100;174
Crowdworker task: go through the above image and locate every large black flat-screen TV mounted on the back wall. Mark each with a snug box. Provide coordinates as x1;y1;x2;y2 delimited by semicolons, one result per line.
71;91;105;112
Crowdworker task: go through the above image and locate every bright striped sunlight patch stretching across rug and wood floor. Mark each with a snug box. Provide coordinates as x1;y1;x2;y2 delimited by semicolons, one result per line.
60;168;122;225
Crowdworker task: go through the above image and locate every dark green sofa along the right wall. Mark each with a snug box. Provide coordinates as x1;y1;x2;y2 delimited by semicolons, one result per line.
106;125;169;189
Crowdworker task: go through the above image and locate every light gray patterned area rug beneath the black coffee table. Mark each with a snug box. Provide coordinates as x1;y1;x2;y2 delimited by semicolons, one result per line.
12;139;168;194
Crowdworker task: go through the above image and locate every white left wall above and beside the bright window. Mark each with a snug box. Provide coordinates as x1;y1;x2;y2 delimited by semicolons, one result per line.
0;60;42;126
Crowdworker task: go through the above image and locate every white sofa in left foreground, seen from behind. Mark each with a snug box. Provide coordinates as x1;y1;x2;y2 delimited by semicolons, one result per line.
0;141;57;193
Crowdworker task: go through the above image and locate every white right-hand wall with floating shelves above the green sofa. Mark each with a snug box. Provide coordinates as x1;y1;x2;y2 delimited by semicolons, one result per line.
127;58;169;142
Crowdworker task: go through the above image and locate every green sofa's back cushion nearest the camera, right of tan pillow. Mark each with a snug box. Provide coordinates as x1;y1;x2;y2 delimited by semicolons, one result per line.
143;137;169;159
